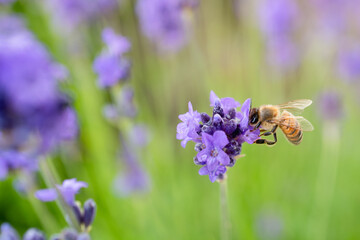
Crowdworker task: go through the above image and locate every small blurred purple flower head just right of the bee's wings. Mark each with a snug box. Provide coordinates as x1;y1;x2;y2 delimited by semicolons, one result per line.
317;90;344;121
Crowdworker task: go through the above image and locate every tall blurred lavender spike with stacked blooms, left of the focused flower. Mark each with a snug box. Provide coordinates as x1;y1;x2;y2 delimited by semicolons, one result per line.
94;28;150;197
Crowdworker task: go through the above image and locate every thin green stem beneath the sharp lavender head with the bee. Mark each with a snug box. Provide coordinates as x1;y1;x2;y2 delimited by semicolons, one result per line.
219;175;231;240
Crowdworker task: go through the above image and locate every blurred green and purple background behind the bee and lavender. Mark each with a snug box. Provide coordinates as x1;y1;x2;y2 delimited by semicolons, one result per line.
0;0;360;239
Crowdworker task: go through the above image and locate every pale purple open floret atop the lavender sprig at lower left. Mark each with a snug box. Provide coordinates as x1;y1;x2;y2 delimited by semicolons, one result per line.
35;178;88;206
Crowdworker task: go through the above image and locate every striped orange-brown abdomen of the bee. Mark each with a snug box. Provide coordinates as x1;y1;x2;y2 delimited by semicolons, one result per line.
279;111;303;145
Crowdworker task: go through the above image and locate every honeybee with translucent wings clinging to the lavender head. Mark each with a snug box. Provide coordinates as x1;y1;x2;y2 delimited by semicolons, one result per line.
249;99;314;145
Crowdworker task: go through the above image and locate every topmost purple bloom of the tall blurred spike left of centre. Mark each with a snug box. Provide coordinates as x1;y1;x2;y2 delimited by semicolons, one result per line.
94;28;131;88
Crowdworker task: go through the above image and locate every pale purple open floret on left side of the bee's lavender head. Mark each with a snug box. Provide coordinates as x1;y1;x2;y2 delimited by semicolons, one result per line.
176;102;201;148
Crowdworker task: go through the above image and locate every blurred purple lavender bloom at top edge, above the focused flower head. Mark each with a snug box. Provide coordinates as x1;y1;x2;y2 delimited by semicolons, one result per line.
136;0;193;52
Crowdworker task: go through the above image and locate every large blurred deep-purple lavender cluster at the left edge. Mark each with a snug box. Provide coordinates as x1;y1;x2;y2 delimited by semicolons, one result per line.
0;15;77;183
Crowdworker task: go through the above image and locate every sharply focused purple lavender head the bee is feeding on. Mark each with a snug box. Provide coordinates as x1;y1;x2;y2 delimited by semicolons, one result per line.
176;91;260;182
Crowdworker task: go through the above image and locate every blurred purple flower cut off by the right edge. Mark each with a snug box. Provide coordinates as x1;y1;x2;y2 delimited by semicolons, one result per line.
338;48;360;83
